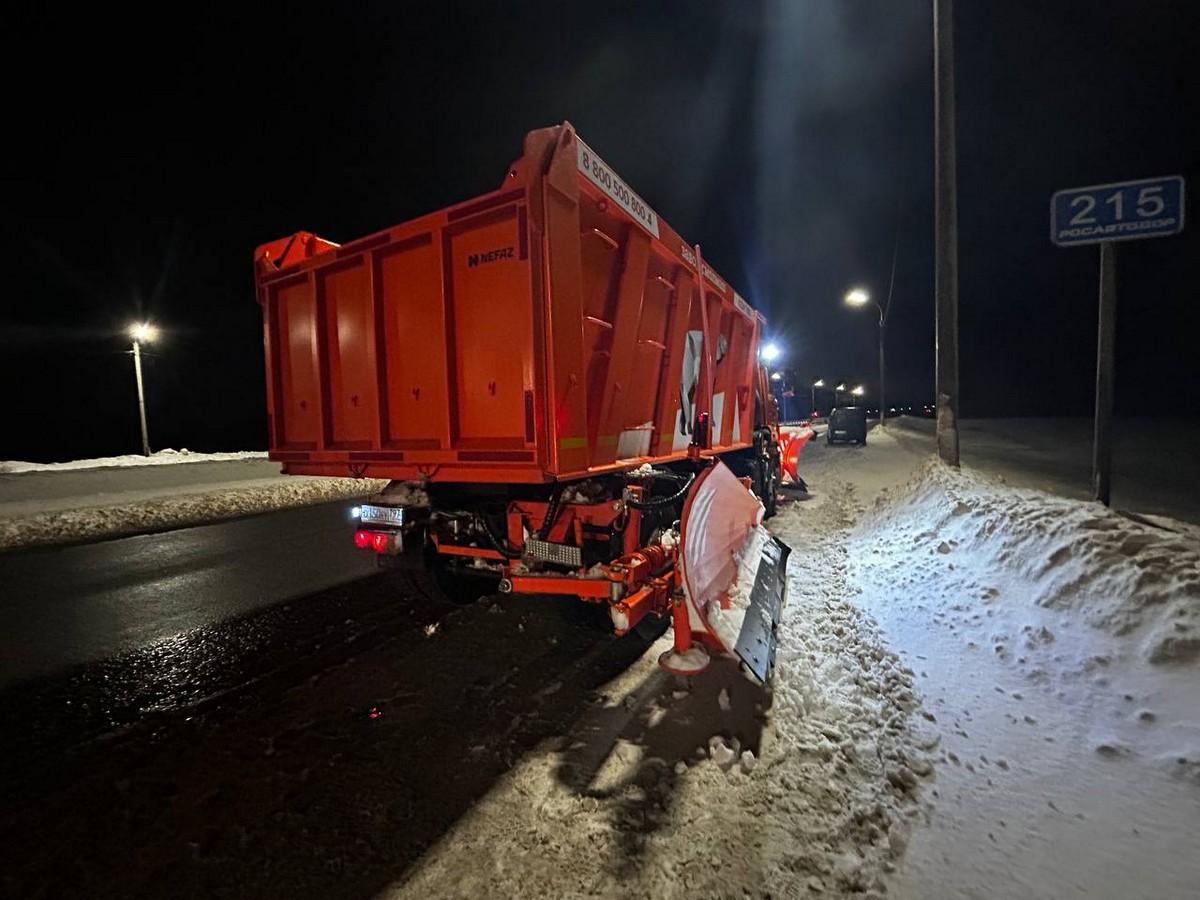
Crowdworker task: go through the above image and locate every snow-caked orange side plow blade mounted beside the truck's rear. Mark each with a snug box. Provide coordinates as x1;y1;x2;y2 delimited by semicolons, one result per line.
659;462;791;682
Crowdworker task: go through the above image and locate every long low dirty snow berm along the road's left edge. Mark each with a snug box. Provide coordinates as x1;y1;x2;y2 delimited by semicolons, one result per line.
0;475;388;550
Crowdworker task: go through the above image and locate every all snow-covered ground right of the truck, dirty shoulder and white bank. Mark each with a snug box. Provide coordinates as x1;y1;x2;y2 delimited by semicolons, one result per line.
380;431;1200;900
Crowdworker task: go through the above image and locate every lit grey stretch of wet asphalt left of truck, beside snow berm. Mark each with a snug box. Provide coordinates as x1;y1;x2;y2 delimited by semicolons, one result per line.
0;501;376;686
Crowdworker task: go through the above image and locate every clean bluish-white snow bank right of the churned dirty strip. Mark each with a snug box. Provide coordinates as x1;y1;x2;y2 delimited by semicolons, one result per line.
805;431;1200;900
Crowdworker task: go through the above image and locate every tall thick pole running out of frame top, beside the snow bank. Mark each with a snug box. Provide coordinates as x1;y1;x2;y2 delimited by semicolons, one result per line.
934;0;959;466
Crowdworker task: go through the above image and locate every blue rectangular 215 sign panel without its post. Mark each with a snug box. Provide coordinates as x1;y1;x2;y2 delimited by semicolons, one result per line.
1050;175;1183;246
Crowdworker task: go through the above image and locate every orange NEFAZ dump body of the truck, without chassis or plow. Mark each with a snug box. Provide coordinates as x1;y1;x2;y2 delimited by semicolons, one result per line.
254;124;774;485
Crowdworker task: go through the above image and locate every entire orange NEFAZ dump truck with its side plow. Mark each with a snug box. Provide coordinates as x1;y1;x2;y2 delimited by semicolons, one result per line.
254;124;787;679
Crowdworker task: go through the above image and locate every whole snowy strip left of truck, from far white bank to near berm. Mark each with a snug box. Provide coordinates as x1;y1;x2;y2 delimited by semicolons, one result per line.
0;451;386;550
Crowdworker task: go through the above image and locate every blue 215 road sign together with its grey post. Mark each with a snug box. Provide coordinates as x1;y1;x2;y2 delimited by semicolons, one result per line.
1050;175;1183;506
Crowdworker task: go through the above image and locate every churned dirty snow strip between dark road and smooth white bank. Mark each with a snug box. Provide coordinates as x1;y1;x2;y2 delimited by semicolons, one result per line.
380;458;938;898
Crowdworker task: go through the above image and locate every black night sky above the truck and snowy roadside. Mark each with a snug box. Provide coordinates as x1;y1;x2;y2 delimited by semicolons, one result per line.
0;0;1200;460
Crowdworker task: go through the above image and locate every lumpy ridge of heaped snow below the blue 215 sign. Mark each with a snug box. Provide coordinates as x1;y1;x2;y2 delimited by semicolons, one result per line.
859;462;1200;664
